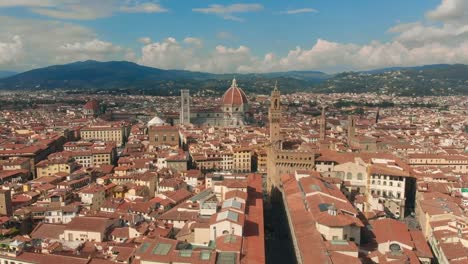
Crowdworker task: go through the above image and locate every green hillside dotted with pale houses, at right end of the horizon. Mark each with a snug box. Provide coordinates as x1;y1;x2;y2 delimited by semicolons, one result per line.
313;64;468;96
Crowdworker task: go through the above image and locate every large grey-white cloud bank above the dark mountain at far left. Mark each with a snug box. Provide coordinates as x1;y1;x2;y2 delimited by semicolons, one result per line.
0;16;124;70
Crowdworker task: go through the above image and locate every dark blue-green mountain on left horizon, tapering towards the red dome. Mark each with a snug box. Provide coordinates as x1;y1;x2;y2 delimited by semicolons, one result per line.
0;61;217;89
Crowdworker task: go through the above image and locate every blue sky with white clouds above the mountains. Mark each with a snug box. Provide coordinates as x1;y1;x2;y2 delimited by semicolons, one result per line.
0;0;468;73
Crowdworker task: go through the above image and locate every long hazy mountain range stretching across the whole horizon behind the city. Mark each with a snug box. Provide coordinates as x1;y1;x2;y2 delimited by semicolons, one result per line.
0;60;468;96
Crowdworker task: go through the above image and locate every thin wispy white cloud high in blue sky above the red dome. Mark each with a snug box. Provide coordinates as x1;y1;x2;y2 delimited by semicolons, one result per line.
192;4;263;21
